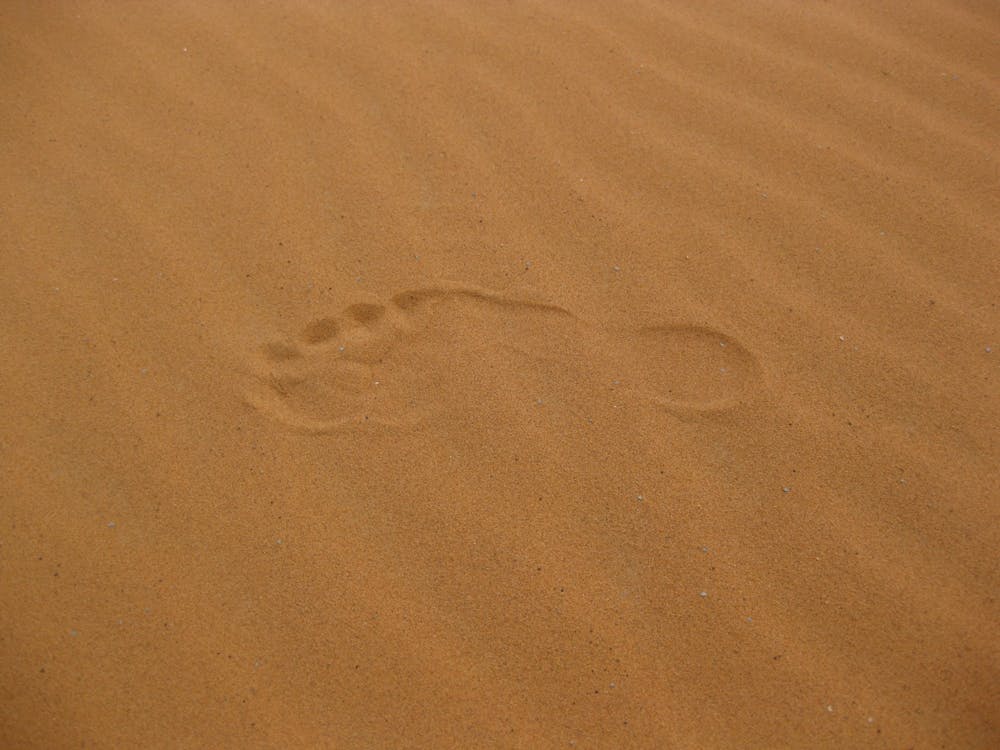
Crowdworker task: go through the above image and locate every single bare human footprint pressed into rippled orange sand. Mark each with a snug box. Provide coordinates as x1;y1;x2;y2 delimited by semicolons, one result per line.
246;285;762;433
